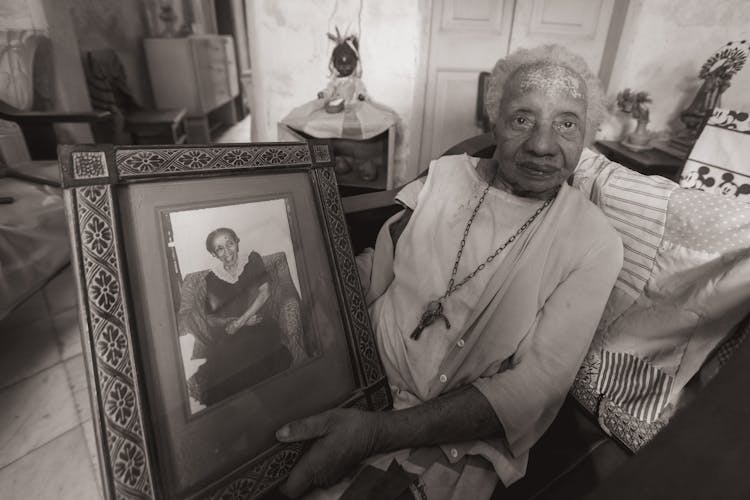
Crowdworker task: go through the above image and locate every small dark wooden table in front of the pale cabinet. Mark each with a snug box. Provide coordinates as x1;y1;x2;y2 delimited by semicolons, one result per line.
126;108;187;144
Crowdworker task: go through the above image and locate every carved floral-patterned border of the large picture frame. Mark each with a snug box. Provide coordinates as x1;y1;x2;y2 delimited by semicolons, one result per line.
60;143;392;499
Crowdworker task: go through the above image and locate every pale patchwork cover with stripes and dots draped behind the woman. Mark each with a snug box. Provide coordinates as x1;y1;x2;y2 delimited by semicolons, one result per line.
571;151;750;451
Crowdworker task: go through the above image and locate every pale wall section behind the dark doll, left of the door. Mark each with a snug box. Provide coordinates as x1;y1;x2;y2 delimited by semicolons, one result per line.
246;0;424;184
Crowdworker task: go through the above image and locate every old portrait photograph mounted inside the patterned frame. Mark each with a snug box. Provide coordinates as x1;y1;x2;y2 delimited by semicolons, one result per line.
166;199;315;414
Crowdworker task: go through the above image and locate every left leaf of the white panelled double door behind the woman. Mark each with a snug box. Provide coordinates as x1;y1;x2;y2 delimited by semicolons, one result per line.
412;0;515;175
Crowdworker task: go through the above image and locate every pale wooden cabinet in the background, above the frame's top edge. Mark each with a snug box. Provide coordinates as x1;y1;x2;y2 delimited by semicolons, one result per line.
143;35;241;143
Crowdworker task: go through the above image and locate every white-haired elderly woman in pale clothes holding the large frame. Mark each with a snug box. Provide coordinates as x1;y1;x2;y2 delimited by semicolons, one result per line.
277;46;622;500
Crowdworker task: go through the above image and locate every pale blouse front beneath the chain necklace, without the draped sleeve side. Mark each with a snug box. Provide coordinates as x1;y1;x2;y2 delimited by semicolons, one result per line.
371;157;543;400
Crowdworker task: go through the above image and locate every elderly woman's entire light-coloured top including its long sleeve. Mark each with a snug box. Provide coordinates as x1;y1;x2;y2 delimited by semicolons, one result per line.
364;155;622;491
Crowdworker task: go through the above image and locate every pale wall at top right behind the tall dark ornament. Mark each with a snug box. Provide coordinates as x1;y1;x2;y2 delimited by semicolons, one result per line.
602;0;750;139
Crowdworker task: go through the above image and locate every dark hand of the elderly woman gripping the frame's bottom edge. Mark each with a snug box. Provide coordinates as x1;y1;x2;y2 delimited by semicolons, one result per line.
276;409;382;498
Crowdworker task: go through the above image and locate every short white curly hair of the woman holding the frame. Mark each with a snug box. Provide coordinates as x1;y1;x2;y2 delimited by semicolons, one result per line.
484;44;607;144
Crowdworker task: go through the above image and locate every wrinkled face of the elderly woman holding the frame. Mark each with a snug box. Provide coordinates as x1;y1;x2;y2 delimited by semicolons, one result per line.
494;64;586;198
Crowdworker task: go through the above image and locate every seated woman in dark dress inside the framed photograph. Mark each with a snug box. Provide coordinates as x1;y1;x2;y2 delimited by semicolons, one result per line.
196;227;292;406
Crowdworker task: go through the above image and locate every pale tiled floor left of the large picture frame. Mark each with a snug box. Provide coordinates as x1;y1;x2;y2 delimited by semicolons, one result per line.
0;266;102;500
